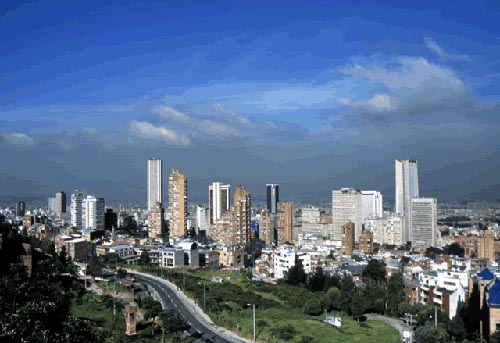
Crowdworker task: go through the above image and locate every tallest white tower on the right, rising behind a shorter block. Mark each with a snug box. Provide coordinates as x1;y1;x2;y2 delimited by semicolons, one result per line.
395;159;419;242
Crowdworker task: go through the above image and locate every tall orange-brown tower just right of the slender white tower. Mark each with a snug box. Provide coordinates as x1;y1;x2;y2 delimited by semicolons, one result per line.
168;168;187;237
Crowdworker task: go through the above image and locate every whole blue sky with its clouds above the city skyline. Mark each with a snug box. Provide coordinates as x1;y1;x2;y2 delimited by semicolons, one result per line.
0;1;500;201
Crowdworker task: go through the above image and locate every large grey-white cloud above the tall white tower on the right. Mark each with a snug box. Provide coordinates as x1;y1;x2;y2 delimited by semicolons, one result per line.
343;56;475;114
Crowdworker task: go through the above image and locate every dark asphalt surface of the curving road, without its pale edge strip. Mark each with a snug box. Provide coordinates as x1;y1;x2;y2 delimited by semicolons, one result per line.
132;273;232;343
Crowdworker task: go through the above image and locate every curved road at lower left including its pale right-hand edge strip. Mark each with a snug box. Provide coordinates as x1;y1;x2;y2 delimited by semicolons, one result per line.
129;271;250;343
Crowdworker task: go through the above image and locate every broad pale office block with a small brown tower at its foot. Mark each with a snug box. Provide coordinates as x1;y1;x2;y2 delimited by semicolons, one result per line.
329;188;363;241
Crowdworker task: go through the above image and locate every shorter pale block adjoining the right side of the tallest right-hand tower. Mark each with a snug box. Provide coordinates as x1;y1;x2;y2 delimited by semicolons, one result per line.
411;198;437;248
